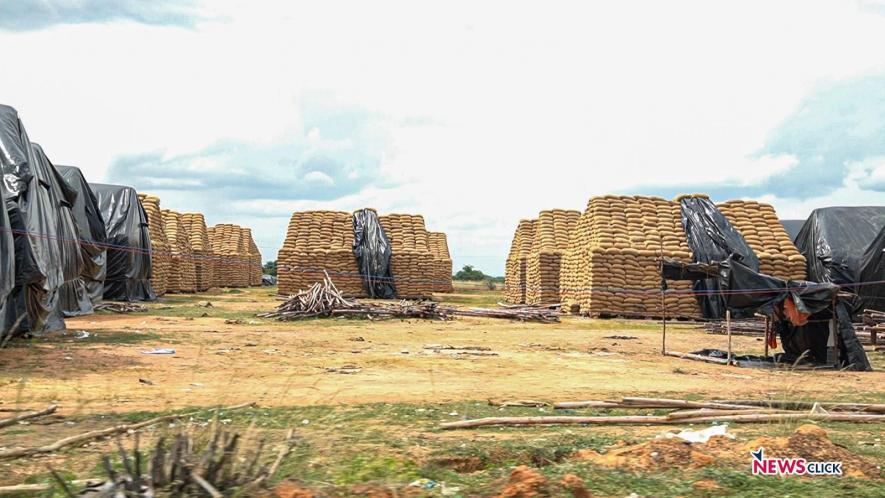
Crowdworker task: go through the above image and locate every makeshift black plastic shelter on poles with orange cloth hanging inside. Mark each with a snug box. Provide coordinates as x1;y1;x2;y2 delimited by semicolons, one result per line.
661;257;871;370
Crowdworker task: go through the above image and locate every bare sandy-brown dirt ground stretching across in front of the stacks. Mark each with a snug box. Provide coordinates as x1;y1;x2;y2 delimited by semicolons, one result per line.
0;288;885;414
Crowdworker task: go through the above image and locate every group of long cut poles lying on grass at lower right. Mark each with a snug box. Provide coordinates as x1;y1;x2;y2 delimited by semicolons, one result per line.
440;398;885;429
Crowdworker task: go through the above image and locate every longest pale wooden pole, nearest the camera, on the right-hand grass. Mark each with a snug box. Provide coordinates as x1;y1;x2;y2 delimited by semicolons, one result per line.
439;413;885;429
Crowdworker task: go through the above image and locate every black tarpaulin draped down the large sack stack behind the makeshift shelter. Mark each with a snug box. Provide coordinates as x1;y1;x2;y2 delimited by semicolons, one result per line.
679;197;759;318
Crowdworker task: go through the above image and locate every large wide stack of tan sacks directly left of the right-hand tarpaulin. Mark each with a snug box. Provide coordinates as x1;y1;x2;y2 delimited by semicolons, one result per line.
560;195;699;317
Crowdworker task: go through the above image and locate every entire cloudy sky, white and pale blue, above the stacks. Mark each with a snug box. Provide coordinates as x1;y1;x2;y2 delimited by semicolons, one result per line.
0;0;885;274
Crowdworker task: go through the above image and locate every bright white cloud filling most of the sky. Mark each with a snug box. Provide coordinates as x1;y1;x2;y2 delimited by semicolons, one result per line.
0;0;885;273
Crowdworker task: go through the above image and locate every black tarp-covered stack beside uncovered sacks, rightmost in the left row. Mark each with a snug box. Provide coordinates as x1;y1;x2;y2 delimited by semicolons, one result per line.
89;183;157;301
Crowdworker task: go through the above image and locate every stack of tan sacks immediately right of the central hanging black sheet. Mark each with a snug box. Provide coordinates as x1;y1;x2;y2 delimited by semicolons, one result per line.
378;214;434;298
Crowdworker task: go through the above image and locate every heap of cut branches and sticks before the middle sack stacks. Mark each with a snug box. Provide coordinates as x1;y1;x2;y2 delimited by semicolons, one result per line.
257;274;559;323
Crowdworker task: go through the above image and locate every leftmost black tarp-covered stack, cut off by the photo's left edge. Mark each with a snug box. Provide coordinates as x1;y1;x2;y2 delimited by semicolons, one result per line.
0;105;64;338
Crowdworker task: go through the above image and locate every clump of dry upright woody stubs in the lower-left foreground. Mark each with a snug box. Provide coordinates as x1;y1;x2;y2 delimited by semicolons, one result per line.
68;421;298;498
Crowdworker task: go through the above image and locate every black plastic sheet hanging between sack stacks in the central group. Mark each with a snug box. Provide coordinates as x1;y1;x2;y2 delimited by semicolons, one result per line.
353;209;396;299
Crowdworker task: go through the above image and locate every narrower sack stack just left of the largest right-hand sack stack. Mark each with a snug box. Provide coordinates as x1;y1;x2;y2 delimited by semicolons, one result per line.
525;209;581;304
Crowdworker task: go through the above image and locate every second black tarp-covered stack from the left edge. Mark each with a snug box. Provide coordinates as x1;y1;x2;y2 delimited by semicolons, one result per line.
28;144;85;330
